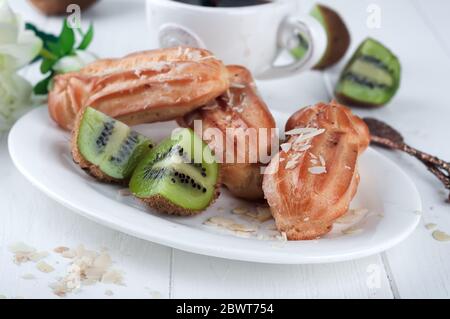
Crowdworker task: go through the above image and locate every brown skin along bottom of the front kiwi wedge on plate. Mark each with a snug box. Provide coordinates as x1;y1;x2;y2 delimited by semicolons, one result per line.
139;179;222;217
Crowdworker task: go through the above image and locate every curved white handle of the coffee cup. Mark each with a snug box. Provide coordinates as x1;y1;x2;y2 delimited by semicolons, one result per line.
258;16;328;79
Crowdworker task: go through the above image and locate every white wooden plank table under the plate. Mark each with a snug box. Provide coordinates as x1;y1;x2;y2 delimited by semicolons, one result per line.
0;0;450;298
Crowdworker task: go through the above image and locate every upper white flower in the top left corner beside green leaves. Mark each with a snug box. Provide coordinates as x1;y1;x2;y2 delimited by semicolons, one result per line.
0;0;42;71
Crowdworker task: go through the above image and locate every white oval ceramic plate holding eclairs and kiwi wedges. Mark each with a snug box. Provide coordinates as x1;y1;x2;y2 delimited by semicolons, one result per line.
9;107;421;264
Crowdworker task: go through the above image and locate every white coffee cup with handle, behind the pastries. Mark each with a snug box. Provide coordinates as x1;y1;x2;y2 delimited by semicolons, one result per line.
147;0;327;79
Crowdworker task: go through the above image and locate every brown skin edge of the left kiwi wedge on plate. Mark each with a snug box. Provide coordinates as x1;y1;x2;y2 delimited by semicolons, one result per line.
71;108;128;185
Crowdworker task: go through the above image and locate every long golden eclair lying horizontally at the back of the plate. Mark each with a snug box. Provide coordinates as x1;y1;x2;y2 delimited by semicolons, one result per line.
48;47;229;129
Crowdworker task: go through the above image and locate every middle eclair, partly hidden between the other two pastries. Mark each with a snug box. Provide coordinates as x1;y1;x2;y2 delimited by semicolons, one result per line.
179;65;276;200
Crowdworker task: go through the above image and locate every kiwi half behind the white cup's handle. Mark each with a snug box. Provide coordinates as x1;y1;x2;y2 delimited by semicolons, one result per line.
291;4;351;70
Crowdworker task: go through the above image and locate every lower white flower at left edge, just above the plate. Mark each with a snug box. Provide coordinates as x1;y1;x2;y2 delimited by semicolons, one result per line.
0;71;32;132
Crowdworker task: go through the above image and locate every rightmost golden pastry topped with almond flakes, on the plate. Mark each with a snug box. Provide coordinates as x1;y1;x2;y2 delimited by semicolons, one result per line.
263;101;370;240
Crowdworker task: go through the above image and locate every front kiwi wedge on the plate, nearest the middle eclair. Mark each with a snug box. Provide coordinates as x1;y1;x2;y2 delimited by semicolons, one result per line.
130;128;219;215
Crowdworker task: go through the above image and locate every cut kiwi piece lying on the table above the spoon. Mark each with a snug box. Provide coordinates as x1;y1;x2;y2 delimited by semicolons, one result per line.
336;38;401;106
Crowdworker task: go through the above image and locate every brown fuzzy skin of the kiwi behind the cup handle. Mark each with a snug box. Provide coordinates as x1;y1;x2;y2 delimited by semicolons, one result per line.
314;5;351;70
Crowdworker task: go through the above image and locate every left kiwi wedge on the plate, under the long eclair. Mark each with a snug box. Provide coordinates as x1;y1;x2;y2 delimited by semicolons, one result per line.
72;107;153;182
